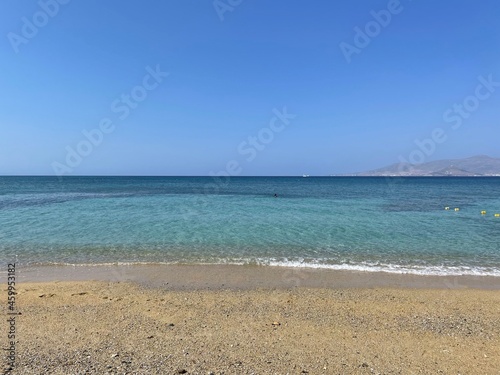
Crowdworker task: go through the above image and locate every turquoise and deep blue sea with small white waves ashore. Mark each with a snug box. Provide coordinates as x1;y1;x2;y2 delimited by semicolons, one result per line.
0;177;500;276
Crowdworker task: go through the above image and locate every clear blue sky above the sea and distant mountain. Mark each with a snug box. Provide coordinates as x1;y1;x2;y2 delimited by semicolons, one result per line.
0;0;500;175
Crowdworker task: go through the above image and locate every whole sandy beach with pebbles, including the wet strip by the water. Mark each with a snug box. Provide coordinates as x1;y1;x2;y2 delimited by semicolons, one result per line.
0;266;500;374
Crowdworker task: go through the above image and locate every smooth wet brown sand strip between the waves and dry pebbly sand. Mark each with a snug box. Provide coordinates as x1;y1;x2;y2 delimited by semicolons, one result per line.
12;264;500;290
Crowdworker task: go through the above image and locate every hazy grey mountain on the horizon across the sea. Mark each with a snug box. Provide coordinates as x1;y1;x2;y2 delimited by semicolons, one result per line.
354;155;500;176
